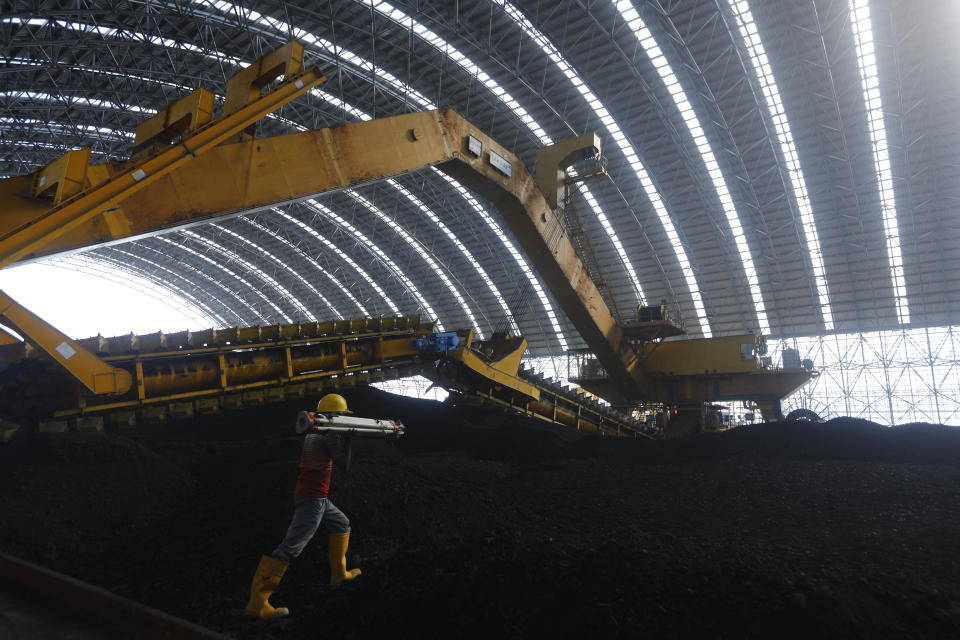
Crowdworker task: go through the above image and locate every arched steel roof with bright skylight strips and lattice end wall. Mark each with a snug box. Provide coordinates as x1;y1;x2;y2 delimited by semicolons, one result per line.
0;0;960;422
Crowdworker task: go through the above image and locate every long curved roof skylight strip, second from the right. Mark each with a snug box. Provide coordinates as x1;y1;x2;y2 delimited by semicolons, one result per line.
729;0;833;331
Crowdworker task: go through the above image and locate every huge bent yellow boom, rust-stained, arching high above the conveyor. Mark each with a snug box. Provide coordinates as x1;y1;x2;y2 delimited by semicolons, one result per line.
0;103;645;396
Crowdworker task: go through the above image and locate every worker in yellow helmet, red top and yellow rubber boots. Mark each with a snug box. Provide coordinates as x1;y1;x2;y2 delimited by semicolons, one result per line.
246;393;360;619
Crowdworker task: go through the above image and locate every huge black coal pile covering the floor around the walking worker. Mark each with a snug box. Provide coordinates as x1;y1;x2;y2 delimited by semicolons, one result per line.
0;389;960;638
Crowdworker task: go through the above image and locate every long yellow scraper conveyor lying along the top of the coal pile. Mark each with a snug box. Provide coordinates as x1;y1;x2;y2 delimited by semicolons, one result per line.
0;316;648;437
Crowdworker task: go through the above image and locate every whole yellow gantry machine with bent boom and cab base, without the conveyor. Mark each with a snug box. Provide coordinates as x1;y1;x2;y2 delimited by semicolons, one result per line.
0;42;809;438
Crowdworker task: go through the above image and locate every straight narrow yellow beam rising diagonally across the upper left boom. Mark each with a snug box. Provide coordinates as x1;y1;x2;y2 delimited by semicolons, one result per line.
0;44;325;268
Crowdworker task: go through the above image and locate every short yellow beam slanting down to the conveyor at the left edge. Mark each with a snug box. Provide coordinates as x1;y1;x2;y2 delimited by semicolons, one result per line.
0;291;133;394
